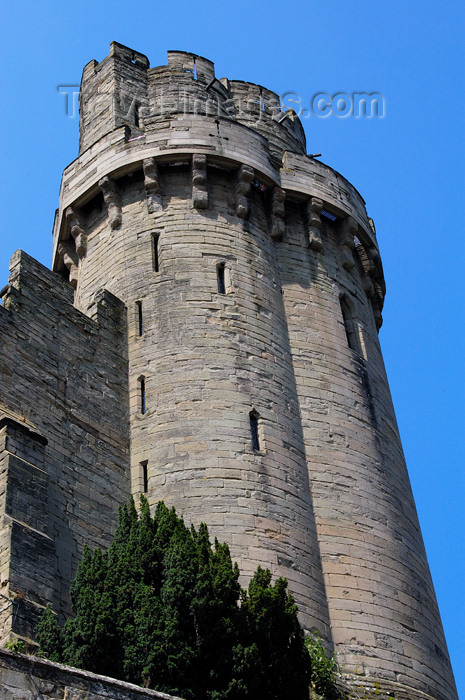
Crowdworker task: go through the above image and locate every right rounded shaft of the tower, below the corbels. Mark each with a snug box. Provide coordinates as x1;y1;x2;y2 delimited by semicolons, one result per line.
279;210;454;699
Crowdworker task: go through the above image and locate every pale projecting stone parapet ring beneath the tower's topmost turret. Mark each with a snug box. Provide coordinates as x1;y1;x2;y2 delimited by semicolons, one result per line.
54;145;377;278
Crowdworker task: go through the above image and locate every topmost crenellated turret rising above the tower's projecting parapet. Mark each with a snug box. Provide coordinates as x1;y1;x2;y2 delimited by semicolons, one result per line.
80;42;305;158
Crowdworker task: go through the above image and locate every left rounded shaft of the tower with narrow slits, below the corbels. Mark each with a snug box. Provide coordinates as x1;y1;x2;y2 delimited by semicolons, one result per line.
70;163;331;639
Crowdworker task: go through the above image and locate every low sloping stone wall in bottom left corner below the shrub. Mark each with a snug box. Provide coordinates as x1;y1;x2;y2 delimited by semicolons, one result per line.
0;649;181;700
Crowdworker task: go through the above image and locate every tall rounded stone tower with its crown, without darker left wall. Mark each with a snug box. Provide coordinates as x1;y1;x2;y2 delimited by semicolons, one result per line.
54;43;456;700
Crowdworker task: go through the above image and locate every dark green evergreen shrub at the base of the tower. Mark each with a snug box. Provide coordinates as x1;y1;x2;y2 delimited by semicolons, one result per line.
38;498;311;700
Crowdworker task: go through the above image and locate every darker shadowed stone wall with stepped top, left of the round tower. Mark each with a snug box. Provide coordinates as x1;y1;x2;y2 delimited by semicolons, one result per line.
0;251;129;637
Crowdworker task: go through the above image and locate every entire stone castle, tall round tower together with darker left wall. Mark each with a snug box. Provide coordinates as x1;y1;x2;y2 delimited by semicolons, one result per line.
0;42;457;700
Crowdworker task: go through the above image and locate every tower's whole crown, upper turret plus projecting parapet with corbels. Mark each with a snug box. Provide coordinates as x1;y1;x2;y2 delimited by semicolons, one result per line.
54;42;384;324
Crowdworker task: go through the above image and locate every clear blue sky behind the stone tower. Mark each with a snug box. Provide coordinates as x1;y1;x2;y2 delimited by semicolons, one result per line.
0;0;465;697
